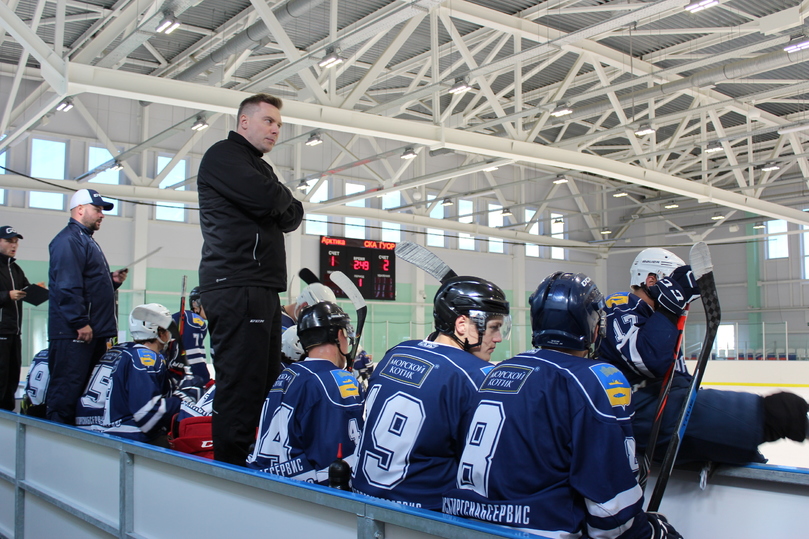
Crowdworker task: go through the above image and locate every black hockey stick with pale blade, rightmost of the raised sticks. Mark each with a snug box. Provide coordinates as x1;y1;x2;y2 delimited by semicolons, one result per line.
646;242;722;511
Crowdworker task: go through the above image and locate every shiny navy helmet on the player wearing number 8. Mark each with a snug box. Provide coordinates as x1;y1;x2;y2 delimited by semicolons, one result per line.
528;271;605;350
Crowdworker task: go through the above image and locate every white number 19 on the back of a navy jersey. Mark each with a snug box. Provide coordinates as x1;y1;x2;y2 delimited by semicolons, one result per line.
362;392;424;489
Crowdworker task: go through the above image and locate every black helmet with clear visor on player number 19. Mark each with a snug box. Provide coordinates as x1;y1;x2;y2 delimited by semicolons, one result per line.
433;276;511;351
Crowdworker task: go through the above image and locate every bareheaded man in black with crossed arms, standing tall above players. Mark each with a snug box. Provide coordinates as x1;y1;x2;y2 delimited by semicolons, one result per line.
197;94;303;466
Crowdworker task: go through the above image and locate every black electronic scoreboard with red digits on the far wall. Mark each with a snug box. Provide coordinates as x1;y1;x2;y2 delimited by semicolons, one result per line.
320;236;396;301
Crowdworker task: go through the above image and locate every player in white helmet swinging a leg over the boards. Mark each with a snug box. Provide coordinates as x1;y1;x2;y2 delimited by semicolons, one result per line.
600;248;809;464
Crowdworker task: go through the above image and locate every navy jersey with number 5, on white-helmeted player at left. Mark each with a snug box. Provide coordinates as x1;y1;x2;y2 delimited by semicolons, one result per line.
76;342;180;442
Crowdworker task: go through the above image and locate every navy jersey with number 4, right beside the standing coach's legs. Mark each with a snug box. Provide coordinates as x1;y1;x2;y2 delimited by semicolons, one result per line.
247;358;363;485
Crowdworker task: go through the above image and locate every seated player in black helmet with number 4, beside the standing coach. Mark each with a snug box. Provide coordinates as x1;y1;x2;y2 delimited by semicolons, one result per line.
247;301;363;485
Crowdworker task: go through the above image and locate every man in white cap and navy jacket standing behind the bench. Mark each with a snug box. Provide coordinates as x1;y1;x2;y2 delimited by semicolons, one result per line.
46;189;126;425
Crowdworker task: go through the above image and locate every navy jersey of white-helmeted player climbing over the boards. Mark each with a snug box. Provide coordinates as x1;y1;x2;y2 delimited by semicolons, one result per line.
599;292;687;385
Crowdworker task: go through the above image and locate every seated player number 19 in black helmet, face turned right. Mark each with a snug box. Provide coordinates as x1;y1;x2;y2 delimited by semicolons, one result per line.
353;277;511;511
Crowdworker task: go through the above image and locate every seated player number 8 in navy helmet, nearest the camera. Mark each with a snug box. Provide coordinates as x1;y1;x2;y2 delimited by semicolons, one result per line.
443;272;681;539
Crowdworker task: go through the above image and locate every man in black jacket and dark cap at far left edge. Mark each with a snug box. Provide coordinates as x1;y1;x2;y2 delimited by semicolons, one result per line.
0;226;29;410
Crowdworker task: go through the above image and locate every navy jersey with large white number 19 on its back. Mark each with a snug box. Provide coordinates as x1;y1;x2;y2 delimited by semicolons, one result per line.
352;341;492;510
